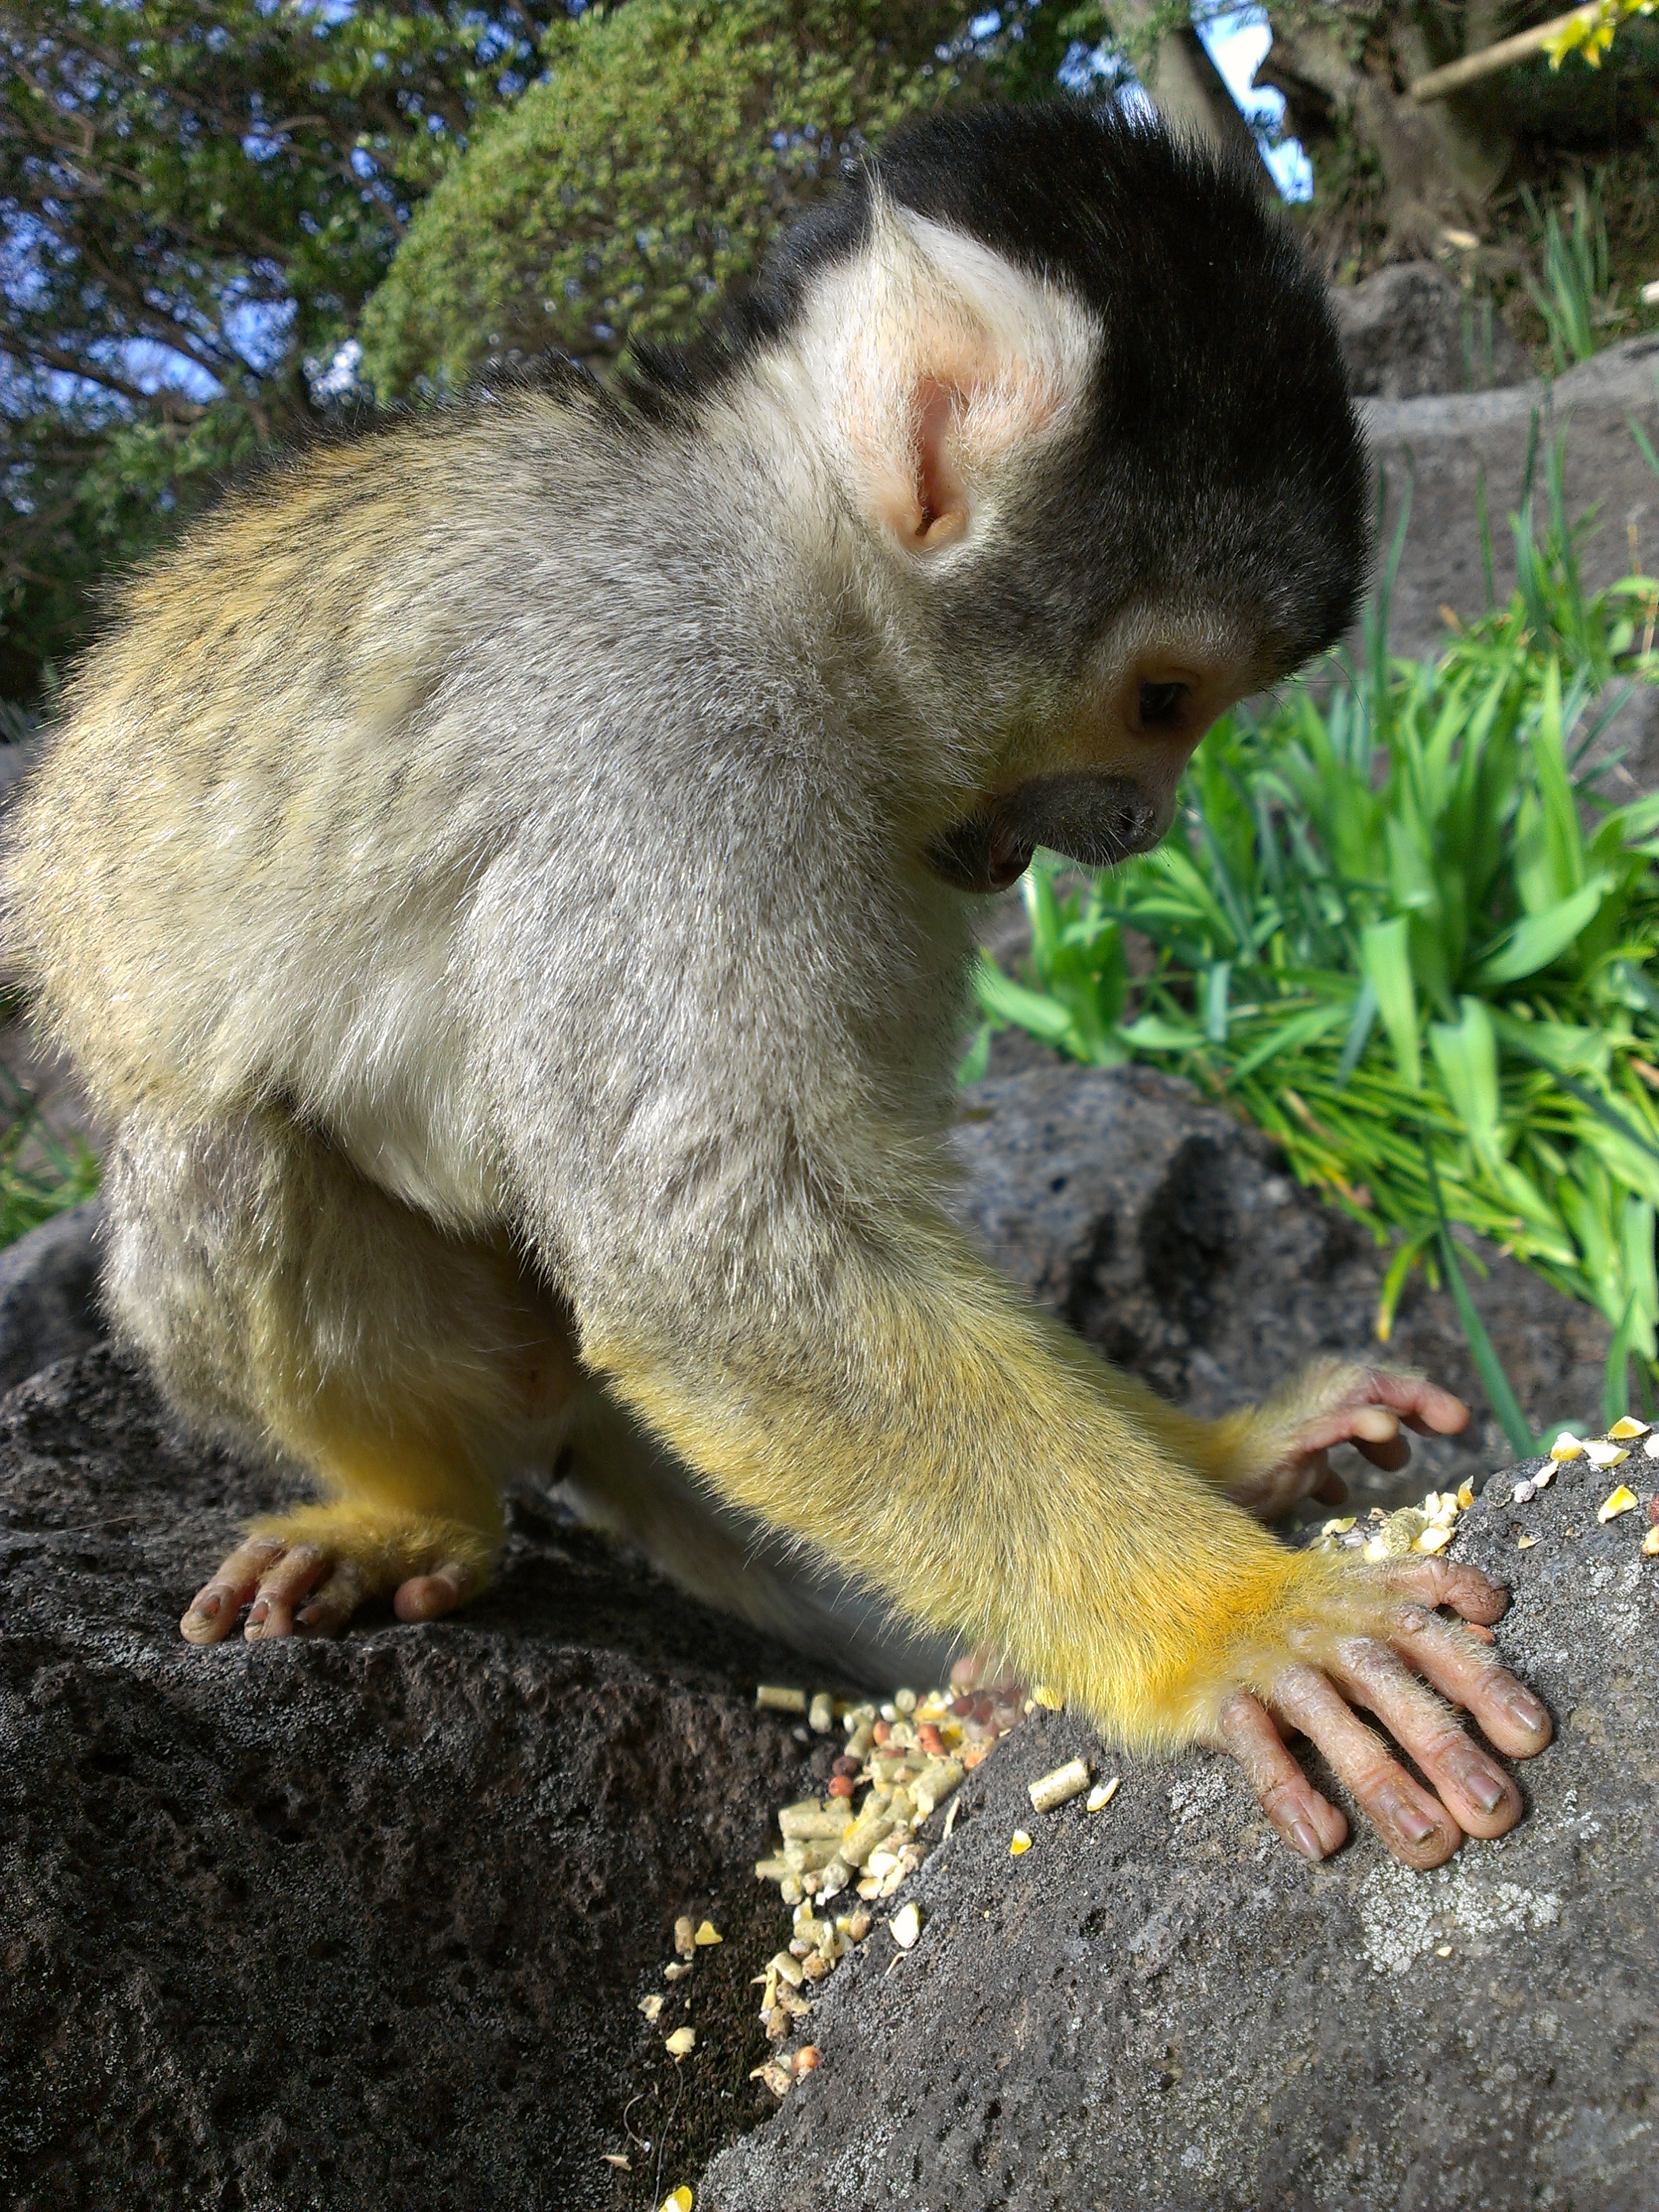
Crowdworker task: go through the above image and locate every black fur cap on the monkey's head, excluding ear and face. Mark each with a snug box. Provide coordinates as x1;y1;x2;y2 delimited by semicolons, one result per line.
648;100;1369;677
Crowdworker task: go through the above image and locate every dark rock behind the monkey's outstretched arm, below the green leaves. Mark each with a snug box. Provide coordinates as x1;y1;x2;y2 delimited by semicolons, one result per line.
958;1038;1608;1504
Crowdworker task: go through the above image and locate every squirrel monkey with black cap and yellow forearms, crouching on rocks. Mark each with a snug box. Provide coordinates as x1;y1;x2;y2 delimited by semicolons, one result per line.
7;104;1549;1867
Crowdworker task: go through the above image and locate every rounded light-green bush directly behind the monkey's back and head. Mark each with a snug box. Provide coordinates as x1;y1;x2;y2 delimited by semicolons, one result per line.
363;0;1090;398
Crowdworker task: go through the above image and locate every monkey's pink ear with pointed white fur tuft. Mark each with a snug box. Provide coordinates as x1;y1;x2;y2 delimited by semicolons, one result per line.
803;201;1101;560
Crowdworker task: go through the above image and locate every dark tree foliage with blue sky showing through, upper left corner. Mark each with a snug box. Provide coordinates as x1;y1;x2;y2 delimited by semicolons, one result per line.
0;0;562;697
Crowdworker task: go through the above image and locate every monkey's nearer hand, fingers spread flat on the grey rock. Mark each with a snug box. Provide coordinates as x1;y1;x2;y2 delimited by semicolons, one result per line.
1204;1559;1551;1867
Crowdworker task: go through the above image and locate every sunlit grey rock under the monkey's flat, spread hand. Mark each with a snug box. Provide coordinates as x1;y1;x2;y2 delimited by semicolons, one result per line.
697;1462;1659;2212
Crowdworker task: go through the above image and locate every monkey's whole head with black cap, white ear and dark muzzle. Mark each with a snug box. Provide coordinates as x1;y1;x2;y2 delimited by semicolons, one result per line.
708;104;1367;891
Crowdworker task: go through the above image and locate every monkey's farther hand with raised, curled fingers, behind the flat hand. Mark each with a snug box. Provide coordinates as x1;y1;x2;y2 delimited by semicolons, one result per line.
1216;1360;1469;1519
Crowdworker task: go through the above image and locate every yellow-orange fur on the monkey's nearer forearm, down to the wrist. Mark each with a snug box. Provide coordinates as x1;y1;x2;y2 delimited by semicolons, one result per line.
584;1239;1330;1745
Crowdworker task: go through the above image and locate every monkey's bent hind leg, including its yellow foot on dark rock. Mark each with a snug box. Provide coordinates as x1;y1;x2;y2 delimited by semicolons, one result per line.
106;1111;577;1643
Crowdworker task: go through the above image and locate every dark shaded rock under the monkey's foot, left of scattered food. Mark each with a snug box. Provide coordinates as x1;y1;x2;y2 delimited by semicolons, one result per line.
0;1351;827;2212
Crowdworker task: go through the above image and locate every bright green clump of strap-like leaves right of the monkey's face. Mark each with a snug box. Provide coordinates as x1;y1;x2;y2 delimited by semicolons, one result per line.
964;447;1659;1449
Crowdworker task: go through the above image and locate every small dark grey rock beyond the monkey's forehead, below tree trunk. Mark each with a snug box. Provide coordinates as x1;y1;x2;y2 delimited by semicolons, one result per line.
1330;261;1533;401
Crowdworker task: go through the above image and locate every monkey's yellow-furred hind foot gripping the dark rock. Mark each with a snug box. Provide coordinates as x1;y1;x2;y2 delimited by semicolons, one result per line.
179;1504;495;1643
